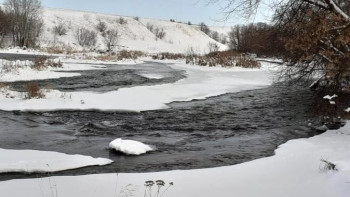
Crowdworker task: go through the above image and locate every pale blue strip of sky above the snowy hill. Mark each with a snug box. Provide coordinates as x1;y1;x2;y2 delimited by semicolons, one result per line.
0;0;272;26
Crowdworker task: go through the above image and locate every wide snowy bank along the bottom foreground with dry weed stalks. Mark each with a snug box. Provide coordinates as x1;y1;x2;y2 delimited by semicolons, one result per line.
0;124;350;197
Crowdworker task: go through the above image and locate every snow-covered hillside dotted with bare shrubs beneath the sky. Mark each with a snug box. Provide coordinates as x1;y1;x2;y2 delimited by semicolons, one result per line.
41;8;227;53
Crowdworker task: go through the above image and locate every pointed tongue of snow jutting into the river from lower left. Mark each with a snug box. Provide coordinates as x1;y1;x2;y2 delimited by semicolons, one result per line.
0;149;113;173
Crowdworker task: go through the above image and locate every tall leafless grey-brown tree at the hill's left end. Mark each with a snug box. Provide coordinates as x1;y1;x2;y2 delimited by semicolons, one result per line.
4;0;43;47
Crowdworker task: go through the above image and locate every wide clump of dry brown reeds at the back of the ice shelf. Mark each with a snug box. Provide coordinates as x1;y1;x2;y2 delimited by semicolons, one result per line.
186;51;261;68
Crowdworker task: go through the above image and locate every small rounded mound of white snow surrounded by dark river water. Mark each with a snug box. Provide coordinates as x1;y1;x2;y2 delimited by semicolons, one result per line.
109;138;153;155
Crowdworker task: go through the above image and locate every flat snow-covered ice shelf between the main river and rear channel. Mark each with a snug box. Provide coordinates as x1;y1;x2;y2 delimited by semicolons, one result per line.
0;63;272;111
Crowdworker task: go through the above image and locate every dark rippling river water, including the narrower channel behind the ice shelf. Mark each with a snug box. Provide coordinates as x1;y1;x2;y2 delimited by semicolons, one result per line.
0;56;324;180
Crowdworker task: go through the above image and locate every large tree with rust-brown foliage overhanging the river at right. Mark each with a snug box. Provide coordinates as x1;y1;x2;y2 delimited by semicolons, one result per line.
216;0;350;92
